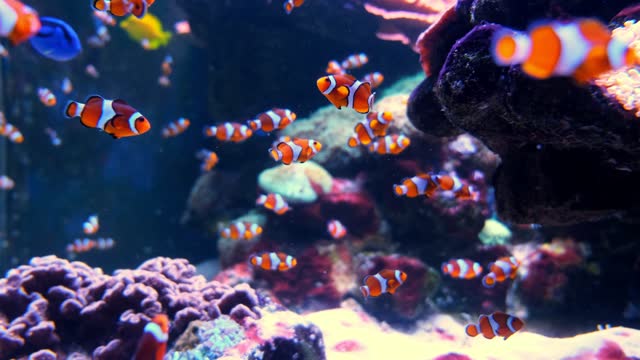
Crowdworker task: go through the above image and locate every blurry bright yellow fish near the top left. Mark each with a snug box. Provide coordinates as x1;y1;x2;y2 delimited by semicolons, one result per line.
120;13;171;50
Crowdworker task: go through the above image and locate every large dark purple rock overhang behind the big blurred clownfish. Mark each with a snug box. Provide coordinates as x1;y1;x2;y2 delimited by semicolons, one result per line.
408;0;640;224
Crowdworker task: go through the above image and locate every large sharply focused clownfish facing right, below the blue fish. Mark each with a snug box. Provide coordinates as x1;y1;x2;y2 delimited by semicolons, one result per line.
64;95;151;139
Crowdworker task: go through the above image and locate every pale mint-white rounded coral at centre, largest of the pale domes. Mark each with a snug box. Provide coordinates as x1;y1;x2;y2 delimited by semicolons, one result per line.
258;161;333;204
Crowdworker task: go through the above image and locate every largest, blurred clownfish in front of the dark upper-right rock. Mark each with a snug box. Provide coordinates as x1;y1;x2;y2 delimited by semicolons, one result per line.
491;19;638;83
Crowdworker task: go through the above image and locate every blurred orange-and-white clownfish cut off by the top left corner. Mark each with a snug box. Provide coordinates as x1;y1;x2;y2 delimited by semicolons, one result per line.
0;0;42;46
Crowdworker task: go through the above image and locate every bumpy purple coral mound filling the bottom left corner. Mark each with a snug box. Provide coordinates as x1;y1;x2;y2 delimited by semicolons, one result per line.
0;256;260;359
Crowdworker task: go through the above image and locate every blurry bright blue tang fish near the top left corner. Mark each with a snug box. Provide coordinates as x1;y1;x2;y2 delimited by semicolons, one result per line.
30;17;82;61
